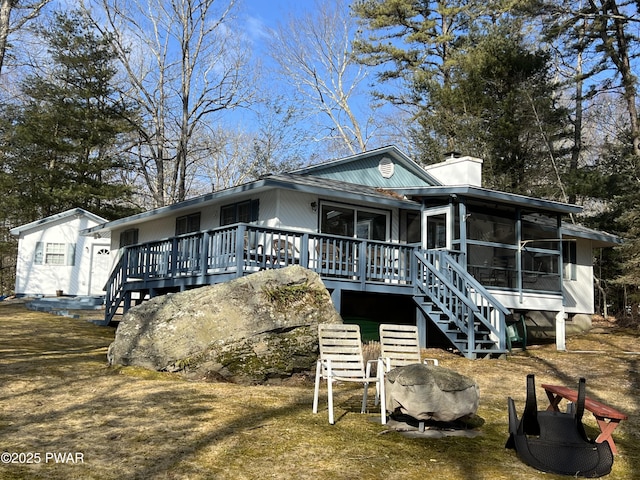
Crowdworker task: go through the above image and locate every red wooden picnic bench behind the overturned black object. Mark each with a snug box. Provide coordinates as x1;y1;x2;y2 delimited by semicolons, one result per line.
542;384;627;455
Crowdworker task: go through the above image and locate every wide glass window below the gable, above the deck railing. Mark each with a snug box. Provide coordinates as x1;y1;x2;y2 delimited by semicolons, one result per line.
320;204;389;241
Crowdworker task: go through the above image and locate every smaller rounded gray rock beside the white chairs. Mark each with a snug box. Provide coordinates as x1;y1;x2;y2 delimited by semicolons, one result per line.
385;364;480;422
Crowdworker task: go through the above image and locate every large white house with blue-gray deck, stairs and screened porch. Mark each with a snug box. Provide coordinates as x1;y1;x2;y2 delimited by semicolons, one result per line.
76;146;620;357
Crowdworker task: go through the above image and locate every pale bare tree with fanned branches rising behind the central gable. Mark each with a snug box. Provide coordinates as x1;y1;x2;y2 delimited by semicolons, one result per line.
269;0;373;153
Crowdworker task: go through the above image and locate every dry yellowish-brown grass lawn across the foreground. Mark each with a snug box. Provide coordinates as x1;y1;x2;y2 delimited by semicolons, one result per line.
0;302;640;480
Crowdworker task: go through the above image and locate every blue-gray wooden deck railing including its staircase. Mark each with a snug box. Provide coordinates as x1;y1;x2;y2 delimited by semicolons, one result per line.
105;224;509;356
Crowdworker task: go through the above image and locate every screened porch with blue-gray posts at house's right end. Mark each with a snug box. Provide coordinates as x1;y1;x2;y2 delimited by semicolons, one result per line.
399;186;581;312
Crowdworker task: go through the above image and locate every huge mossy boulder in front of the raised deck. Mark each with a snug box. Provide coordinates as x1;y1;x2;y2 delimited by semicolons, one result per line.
107;266;342;382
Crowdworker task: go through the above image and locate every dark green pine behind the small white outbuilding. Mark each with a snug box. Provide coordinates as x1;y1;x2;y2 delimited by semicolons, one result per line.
2;9;134;221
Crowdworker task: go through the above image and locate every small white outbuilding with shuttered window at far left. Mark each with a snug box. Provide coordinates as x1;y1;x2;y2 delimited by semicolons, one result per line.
11;208;112;296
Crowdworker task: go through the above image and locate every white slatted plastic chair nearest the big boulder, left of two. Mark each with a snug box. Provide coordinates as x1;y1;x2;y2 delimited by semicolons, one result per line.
313;324;387;425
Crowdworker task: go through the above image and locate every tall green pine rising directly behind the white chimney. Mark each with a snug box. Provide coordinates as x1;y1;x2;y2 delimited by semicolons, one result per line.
354;0;567;200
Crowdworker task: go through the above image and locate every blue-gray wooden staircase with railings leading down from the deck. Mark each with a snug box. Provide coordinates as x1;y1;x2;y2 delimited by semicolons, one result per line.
413;250;510;358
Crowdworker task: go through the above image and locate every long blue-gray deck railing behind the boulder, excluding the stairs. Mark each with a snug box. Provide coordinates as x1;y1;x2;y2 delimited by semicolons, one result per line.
106;224;416;321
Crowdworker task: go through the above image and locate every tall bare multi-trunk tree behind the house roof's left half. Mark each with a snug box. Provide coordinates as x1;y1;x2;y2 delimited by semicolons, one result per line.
85;0;253;206
